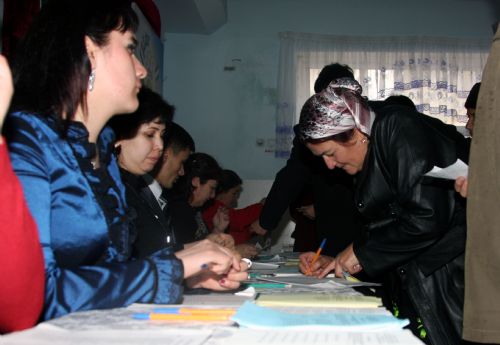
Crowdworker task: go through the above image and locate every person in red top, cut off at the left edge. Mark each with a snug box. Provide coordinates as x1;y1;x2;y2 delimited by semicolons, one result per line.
0;56;45;333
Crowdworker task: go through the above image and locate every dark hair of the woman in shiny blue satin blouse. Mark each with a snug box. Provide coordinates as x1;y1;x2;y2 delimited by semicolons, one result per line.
12;0;138;130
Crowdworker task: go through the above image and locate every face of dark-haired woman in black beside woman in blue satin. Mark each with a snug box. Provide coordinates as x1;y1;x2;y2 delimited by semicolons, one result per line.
116;118;165;175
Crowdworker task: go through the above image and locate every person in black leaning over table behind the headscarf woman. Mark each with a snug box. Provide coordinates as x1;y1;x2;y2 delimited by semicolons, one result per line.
251;63;362;255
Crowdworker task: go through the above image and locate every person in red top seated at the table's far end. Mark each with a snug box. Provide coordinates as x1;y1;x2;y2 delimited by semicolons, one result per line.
203;170;265;245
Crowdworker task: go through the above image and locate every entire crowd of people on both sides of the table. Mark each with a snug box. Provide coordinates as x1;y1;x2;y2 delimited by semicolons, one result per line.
0;0;500;345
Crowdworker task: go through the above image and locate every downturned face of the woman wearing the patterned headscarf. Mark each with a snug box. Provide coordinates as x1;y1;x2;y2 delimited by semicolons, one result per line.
306;130;368;175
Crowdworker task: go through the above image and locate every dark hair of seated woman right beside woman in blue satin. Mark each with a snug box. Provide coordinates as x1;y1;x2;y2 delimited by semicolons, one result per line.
108;87;175;140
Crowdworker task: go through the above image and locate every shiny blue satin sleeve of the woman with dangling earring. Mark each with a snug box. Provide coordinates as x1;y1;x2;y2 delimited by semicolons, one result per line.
9;116;183;319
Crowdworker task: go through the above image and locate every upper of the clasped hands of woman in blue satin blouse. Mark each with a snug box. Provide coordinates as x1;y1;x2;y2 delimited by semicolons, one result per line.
175;240;241;278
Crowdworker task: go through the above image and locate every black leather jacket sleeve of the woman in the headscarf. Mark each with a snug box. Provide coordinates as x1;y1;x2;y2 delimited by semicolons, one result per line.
354;114;456;276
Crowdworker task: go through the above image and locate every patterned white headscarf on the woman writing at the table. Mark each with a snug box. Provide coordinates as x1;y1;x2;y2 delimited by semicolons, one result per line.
299;78;375;141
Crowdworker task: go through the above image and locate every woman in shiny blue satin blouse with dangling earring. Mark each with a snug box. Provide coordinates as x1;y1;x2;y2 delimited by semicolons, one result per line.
6;0;246;320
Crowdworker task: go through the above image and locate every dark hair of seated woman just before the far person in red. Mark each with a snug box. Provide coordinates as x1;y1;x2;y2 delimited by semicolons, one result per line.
174;152;222;198
